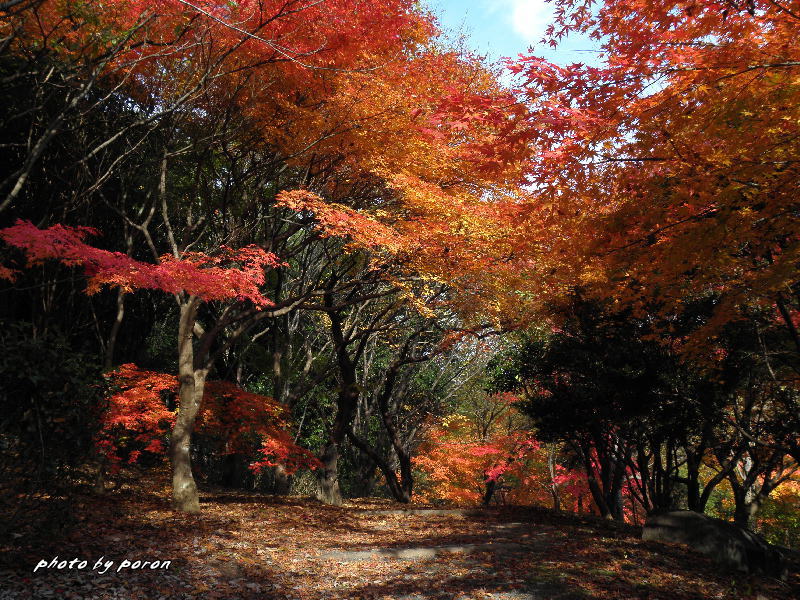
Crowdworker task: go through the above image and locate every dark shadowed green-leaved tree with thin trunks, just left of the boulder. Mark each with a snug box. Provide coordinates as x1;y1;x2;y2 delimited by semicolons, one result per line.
492;295;713;519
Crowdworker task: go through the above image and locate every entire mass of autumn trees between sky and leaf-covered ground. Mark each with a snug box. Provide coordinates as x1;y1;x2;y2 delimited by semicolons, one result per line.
0;0;800;546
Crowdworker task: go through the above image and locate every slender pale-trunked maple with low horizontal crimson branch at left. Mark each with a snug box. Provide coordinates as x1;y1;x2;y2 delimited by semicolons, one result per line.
1;221;296;512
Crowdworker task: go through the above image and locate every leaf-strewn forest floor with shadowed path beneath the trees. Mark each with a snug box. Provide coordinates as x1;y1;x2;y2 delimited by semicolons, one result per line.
0;474;800;600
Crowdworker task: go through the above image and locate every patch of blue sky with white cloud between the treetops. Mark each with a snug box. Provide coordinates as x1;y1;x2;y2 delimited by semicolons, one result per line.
423;0;597;64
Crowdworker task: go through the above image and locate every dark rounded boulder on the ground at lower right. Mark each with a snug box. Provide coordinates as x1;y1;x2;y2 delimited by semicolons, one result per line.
642;510;787;579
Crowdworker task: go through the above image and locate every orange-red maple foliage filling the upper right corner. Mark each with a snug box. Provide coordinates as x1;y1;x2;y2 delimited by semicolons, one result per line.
510;0;800;339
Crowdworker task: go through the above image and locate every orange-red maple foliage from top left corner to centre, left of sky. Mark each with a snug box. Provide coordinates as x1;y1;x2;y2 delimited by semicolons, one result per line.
5;0;531;330
